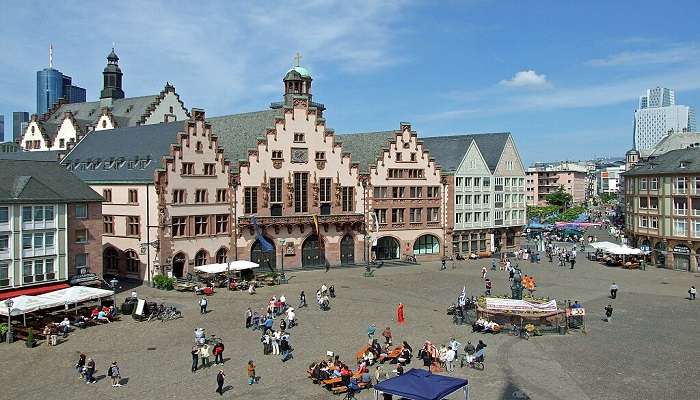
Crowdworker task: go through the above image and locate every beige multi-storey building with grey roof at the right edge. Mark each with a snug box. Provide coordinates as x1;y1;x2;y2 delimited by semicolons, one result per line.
623;148;700;272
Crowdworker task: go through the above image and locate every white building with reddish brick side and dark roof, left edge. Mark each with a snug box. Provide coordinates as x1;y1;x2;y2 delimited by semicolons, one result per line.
0;160;102;298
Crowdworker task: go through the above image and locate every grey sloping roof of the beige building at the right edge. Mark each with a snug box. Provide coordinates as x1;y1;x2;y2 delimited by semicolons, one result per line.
622;147;700;176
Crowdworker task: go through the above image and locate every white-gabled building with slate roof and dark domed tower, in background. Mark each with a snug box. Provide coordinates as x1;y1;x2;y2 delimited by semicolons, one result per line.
19;50;189;151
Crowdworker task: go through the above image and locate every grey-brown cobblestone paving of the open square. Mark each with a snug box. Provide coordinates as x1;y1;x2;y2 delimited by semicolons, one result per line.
0;242;700;400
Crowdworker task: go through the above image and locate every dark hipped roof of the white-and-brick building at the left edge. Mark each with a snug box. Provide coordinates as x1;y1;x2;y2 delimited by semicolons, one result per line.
0;160;103;203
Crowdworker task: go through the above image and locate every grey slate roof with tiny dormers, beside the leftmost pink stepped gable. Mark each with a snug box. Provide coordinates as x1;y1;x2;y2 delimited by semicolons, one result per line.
61;121;186;183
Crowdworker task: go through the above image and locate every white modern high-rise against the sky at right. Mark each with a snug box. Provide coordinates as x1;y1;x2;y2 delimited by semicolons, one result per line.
633;87;695;153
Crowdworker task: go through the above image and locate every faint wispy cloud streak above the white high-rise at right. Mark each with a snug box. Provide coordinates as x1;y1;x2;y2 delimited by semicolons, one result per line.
587;44;700;67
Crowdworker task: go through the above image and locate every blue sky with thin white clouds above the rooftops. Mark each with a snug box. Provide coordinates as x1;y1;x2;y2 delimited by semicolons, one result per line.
0;0;700;163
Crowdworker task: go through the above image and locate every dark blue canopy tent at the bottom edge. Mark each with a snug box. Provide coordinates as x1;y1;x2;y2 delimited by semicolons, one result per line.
374;368;469;400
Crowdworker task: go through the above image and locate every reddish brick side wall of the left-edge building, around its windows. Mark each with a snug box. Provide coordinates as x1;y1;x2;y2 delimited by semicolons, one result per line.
68;203;104;276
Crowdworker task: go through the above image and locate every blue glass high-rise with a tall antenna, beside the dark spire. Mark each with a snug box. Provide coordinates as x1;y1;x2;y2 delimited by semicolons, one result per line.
36;46;86;114
